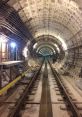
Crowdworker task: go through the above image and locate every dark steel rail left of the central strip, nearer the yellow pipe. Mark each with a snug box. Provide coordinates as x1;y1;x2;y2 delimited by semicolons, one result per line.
8;63;43;117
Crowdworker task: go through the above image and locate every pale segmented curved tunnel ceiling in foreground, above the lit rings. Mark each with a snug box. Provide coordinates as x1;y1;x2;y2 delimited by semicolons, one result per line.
7;0;82;46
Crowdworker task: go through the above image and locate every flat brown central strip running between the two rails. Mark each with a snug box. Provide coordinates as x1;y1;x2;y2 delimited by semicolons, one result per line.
39;62;53;117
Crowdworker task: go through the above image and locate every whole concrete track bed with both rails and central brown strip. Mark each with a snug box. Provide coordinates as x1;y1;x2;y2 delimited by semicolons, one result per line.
0;61;82;117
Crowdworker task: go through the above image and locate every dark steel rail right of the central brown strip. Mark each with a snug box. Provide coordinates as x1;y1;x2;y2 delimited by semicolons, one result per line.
49;63;82;117
